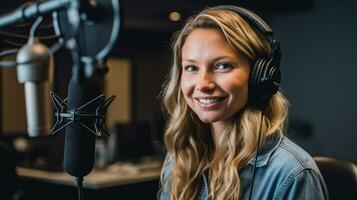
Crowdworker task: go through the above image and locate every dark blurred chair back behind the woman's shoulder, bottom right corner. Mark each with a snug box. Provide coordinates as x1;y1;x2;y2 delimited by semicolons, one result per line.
314;157;357;200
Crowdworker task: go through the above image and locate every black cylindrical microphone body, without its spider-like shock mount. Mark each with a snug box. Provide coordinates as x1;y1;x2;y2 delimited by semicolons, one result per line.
64;76;104;177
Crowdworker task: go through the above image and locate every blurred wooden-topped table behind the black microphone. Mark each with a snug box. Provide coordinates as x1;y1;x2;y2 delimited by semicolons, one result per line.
16;161;161;200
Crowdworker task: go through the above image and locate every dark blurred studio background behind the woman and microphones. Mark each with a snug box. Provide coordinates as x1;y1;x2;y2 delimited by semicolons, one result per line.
0;0;357;199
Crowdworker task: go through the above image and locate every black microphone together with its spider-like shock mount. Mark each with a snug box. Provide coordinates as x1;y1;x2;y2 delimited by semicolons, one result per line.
50;76;115;177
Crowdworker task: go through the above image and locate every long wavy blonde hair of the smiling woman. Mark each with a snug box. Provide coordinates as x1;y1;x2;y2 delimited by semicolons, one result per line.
161;8;288;200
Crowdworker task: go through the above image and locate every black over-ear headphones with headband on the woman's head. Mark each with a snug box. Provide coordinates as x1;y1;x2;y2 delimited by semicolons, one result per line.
214;5;281;108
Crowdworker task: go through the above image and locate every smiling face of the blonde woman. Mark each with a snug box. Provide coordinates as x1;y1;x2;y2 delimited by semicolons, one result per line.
181;28;250;123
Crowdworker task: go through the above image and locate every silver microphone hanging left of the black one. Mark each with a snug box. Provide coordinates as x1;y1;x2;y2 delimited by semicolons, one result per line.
16;38;51;137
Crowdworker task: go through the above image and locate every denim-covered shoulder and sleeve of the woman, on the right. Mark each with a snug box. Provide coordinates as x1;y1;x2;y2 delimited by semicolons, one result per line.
269;137;328;199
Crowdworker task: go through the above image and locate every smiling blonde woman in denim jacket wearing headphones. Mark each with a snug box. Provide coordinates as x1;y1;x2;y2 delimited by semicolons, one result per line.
159;7;328;200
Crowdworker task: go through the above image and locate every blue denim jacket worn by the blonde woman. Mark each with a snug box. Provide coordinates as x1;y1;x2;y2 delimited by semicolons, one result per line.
159;135;328;200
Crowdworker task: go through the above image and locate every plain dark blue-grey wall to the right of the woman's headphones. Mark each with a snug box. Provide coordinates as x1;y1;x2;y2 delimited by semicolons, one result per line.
272;0;357;162
